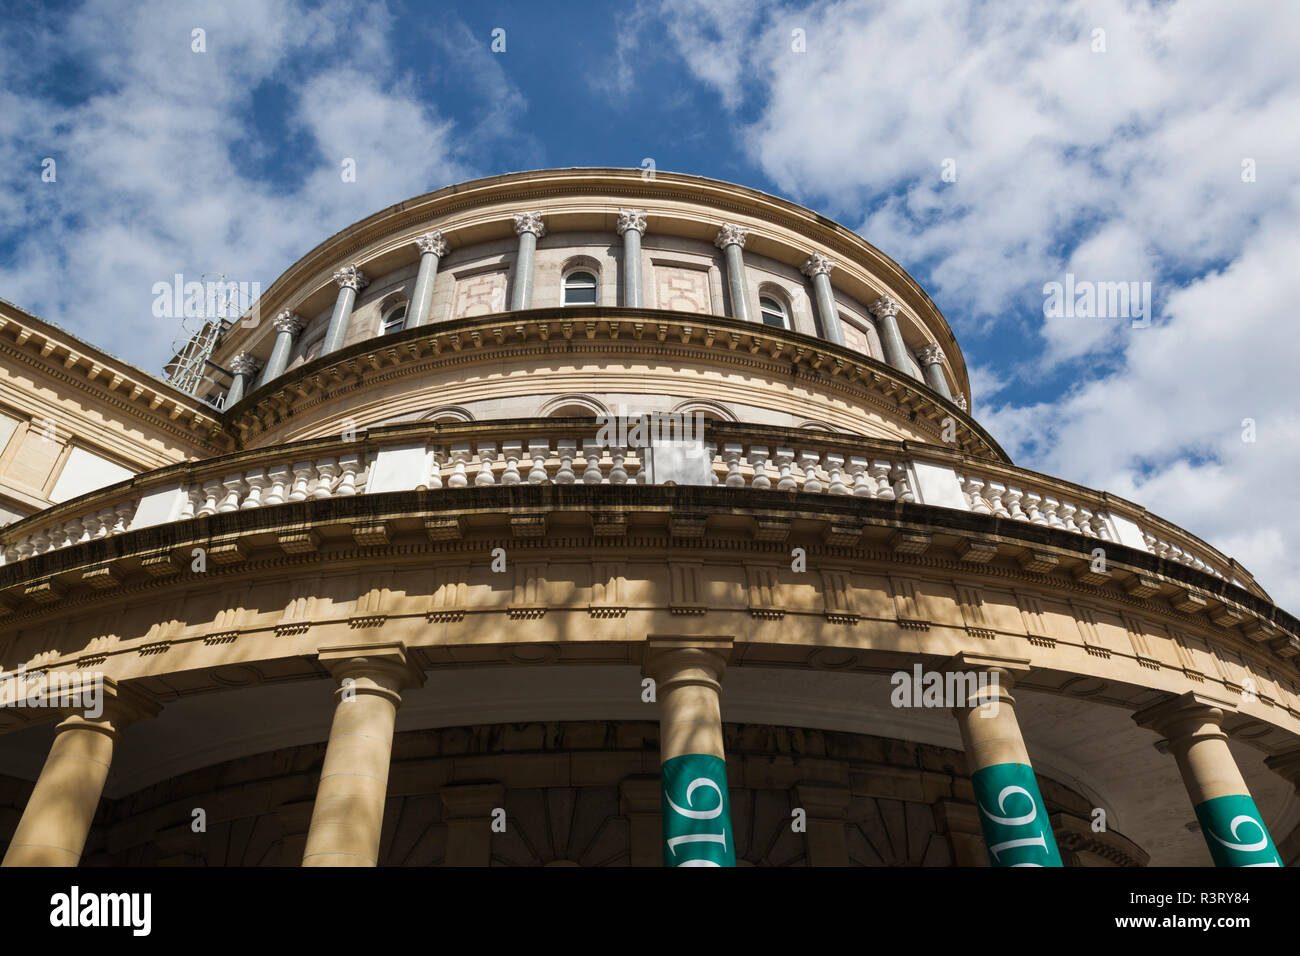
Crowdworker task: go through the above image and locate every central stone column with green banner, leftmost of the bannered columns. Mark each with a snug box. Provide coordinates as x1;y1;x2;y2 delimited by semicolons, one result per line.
642;636;736;866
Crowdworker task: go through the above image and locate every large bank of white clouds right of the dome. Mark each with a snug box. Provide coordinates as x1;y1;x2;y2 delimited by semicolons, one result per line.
662;0;1300;609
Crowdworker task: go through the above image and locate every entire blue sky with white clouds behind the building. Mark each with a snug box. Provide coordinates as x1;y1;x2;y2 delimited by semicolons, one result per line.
0;0;1300;610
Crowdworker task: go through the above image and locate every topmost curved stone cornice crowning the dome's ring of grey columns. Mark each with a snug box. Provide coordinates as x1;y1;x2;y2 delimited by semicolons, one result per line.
210;168;970;394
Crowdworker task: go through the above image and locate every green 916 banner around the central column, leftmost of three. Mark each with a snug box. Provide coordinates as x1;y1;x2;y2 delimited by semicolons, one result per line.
663;753;736;866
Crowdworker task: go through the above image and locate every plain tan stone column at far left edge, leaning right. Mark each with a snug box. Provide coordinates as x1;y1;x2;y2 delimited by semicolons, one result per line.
3;674;159;866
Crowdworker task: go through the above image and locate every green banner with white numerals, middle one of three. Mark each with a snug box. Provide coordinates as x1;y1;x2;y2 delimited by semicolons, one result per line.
971;763;1063;866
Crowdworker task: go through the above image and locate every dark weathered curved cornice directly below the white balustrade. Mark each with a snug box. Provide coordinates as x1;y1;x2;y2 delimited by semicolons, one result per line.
0;481;1300;679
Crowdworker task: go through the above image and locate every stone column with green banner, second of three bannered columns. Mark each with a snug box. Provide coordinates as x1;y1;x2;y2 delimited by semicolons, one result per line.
945;653;1062;866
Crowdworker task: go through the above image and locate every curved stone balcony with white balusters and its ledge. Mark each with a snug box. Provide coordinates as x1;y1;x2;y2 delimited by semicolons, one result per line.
0;419;1300;657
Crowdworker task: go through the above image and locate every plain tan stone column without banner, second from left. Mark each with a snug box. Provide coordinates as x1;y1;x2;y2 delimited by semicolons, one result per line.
303;644;424;866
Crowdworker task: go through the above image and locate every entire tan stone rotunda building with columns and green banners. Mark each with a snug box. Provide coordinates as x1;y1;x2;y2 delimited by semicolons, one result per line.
0;169;1300;866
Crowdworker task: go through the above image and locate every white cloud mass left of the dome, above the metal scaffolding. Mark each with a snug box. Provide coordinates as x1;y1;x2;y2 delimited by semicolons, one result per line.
0;0;523;371
